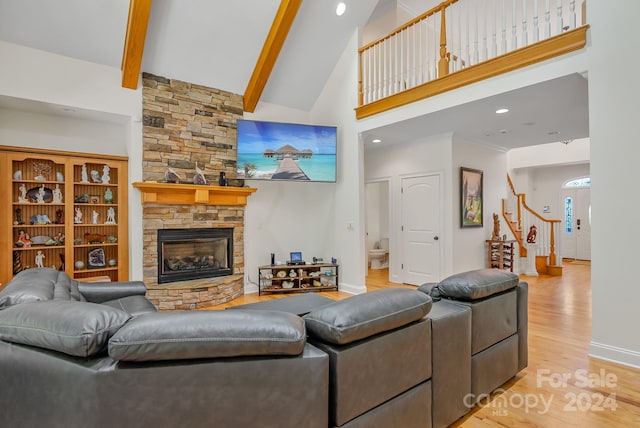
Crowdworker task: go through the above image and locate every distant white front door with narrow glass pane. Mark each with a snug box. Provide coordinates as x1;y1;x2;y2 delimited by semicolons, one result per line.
562;187;591;260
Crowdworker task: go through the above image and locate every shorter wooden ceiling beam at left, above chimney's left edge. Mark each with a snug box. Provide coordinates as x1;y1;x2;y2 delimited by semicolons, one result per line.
120;0;152;89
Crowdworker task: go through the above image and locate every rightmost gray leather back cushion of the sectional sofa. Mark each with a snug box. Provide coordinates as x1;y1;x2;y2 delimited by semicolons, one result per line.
429;269;520;300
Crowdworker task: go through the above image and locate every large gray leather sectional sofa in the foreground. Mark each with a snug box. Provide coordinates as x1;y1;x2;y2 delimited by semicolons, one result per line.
0;269;527;428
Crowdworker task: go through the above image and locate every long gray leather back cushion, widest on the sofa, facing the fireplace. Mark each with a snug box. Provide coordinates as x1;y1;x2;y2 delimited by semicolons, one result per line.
109;310;306;361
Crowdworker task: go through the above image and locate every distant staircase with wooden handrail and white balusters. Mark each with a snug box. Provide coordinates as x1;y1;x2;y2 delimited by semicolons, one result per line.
502;174;562;276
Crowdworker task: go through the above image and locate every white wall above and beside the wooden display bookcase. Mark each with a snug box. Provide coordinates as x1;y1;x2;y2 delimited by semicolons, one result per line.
0;41;142;280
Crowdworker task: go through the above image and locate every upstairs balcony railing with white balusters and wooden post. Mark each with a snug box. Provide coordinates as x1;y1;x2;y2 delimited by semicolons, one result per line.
358;0;586;106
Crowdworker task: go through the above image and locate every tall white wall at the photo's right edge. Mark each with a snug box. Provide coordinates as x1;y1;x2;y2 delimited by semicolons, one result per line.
588;0;640;367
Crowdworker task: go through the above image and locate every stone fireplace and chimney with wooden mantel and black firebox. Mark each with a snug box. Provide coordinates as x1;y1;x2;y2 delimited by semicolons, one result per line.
139;73;255;310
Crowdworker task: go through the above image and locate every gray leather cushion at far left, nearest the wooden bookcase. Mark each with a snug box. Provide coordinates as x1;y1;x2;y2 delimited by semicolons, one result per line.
0;268;58;309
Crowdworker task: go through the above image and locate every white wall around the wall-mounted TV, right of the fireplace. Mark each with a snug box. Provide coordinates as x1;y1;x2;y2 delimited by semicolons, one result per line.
245;30;366;293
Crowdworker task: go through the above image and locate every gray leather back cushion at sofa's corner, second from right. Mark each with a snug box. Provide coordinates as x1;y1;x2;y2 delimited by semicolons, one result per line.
304;288;431;345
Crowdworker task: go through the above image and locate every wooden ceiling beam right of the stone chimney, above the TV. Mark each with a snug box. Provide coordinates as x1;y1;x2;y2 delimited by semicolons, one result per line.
243;0;302;113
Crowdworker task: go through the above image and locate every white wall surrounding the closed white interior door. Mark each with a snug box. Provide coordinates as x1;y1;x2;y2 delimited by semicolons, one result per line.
364;134;453;282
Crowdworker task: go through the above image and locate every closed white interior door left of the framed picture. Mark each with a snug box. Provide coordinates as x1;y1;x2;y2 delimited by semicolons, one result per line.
401;175;442;285
